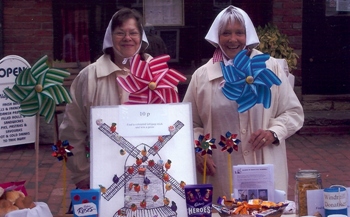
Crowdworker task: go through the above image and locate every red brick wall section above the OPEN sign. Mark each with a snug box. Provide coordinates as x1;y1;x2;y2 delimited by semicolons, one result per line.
3;0;53;64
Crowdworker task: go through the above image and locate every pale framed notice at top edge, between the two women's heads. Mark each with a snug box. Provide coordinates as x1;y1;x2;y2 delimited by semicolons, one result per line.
143;0;185;26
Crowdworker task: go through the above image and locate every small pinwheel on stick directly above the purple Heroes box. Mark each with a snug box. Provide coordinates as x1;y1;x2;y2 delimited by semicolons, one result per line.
194;133;216;184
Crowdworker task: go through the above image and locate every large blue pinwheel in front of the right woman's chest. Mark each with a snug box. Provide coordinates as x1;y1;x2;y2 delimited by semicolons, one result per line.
221;50;282;113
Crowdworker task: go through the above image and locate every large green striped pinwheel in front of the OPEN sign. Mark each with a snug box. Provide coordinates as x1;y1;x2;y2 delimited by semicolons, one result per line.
4;55;72;123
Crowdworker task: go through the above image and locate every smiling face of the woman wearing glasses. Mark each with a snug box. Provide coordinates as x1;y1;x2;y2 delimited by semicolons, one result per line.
112;18;141;58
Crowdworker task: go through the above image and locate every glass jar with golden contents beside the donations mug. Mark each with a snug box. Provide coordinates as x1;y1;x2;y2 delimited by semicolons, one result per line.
295;170;322;216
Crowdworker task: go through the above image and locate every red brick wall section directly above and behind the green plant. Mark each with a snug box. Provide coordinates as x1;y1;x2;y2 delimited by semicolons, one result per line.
273;0;303;76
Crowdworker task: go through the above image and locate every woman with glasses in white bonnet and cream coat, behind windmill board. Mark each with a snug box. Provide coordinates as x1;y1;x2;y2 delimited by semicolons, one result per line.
59;8;151;189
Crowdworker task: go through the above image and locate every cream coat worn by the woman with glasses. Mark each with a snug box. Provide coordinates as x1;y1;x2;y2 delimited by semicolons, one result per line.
59;54;151;183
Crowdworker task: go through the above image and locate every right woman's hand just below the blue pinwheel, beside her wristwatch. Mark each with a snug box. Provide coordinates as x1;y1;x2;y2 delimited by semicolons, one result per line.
248;129;275;151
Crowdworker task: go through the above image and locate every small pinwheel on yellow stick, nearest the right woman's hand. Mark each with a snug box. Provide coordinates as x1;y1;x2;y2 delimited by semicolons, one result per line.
219;131;241;198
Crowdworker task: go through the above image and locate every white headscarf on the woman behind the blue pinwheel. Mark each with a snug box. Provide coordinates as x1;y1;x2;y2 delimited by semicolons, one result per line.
205;5;260;49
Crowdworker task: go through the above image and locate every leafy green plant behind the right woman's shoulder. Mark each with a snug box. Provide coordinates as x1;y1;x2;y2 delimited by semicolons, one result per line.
256;23;299;73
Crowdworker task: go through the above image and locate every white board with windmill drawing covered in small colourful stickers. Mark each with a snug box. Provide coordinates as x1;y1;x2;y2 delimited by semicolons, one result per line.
90;103;197;217
